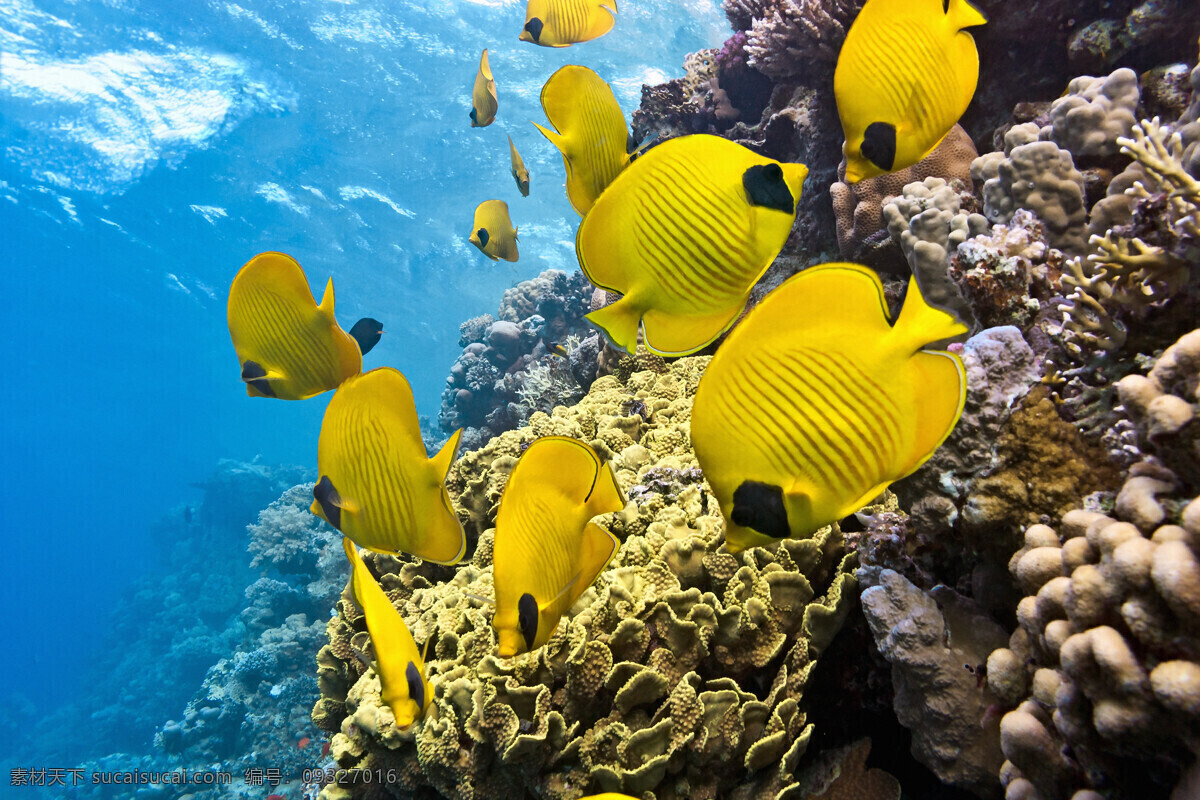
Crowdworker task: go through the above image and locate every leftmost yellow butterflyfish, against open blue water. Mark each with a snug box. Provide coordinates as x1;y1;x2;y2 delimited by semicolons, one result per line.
227;253;383;399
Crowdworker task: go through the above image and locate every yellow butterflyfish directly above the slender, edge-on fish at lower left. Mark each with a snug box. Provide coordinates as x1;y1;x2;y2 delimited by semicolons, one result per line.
311;367;467;564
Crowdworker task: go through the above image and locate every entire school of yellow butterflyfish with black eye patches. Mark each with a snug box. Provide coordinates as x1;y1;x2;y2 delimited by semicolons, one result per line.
228;0;985;743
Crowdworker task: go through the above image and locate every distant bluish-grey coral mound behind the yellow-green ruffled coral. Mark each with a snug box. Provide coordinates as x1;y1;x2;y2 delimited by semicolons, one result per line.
438;270;596;450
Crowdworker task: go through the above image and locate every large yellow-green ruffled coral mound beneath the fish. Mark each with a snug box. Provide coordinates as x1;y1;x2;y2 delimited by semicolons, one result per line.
304;357;856;800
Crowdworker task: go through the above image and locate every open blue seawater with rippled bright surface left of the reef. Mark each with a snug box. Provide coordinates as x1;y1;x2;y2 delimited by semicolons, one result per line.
0;0;728;796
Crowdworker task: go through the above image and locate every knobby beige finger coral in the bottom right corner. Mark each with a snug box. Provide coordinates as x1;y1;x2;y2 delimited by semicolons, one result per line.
988;468;1200;800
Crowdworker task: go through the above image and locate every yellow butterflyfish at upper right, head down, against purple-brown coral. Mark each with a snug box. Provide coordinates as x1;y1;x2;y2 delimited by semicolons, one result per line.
833;0;988;184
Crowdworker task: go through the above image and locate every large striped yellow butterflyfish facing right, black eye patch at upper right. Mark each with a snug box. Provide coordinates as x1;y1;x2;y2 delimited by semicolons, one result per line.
575;134;809;355
